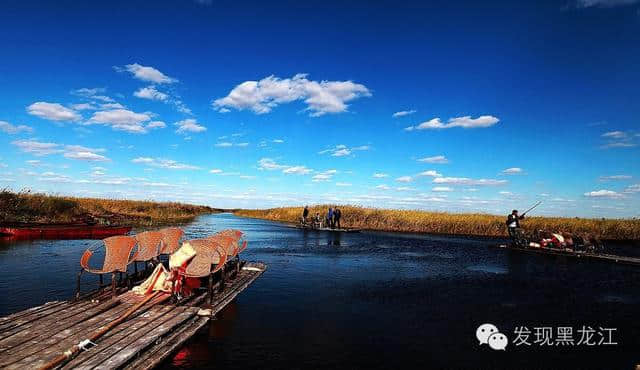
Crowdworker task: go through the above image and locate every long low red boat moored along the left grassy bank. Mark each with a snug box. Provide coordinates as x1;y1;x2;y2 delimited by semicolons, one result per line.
0;224;131;239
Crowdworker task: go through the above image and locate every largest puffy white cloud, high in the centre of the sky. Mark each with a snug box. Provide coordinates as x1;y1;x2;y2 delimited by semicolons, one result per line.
213;74;371;117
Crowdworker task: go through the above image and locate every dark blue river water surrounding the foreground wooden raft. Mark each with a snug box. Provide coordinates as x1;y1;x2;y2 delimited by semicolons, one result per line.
0;214;640;370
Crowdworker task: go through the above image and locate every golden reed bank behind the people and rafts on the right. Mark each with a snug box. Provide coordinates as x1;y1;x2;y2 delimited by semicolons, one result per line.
235;205;640;240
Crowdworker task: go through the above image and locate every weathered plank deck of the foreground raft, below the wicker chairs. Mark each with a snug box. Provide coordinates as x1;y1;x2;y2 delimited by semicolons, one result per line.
0;263;267;369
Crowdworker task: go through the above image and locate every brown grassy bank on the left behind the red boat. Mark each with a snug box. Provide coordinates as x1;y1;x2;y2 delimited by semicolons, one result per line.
0;190;221;226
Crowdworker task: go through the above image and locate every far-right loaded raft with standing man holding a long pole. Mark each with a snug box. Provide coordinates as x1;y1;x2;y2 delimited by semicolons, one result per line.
506;209;604;253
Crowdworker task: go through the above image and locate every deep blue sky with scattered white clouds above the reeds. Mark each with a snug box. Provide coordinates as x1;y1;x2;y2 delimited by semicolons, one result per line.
0;0;640;217
